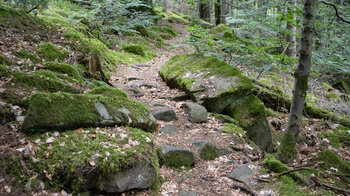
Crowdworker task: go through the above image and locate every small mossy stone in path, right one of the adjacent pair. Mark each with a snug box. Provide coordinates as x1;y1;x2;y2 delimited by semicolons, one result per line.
192;140;220;161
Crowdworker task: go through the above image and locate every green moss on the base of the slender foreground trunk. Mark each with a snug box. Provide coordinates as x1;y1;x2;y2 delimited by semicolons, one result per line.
278;132;296;163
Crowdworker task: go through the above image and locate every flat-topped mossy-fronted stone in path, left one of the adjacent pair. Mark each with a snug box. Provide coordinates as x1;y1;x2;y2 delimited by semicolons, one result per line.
161;144;195;168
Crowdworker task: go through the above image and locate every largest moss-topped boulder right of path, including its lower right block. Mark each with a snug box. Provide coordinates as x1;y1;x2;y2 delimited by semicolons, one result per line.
159;54;272;151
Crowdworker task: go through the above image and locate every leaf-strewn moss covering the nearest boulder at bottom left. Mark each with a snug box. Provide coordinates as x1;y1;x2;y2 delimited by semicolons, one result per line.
26;127;160;192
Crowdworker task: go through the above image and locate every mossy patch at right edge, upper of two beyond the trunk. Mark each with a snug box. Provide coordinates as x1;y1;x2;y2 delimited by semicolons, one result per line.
320;125;350;148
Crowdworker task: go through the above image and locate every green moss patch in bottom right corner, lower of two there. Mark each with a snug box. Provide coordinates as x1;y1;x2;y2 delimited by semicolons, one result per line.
316;150;350;175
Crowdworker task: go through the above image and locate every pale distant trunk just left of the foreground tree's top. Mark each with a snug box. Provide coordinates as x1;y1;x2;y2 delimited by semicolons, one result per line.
285;0;297;58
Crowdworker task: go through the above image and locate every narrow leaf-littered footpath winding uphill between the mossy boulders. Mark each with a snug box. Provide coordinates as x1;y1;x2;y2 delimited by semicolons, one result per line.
110;25;270;195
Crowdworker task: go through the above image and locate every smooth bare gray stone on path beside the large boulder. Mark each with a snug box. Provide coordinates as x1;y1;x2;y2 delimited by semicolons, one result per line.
184;103;208;123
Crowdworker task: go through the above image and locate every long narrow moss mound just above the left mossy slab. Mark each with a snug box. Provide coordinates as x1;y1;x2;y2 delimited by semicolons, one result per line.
45;62;83;82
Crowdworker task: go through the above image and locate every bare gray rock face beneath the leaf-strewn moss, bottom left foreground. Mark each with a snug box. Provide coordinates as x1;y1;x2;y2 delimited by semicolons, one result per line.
97;164;157;193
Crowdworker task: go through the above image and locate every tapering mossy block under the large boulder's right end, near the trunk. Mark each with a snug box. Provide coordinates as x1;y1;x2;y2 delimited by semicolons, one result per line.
225;95;272;151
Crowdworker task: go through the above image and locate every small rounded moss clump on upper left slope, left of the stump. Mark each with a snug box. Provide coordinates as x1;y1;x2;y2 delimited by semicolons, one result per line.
37;42;67;61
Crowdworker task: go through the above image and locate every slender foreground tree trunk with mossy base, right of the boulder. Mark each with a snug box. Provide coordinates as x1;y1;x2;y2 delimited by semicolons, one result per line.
278;0;317;163
